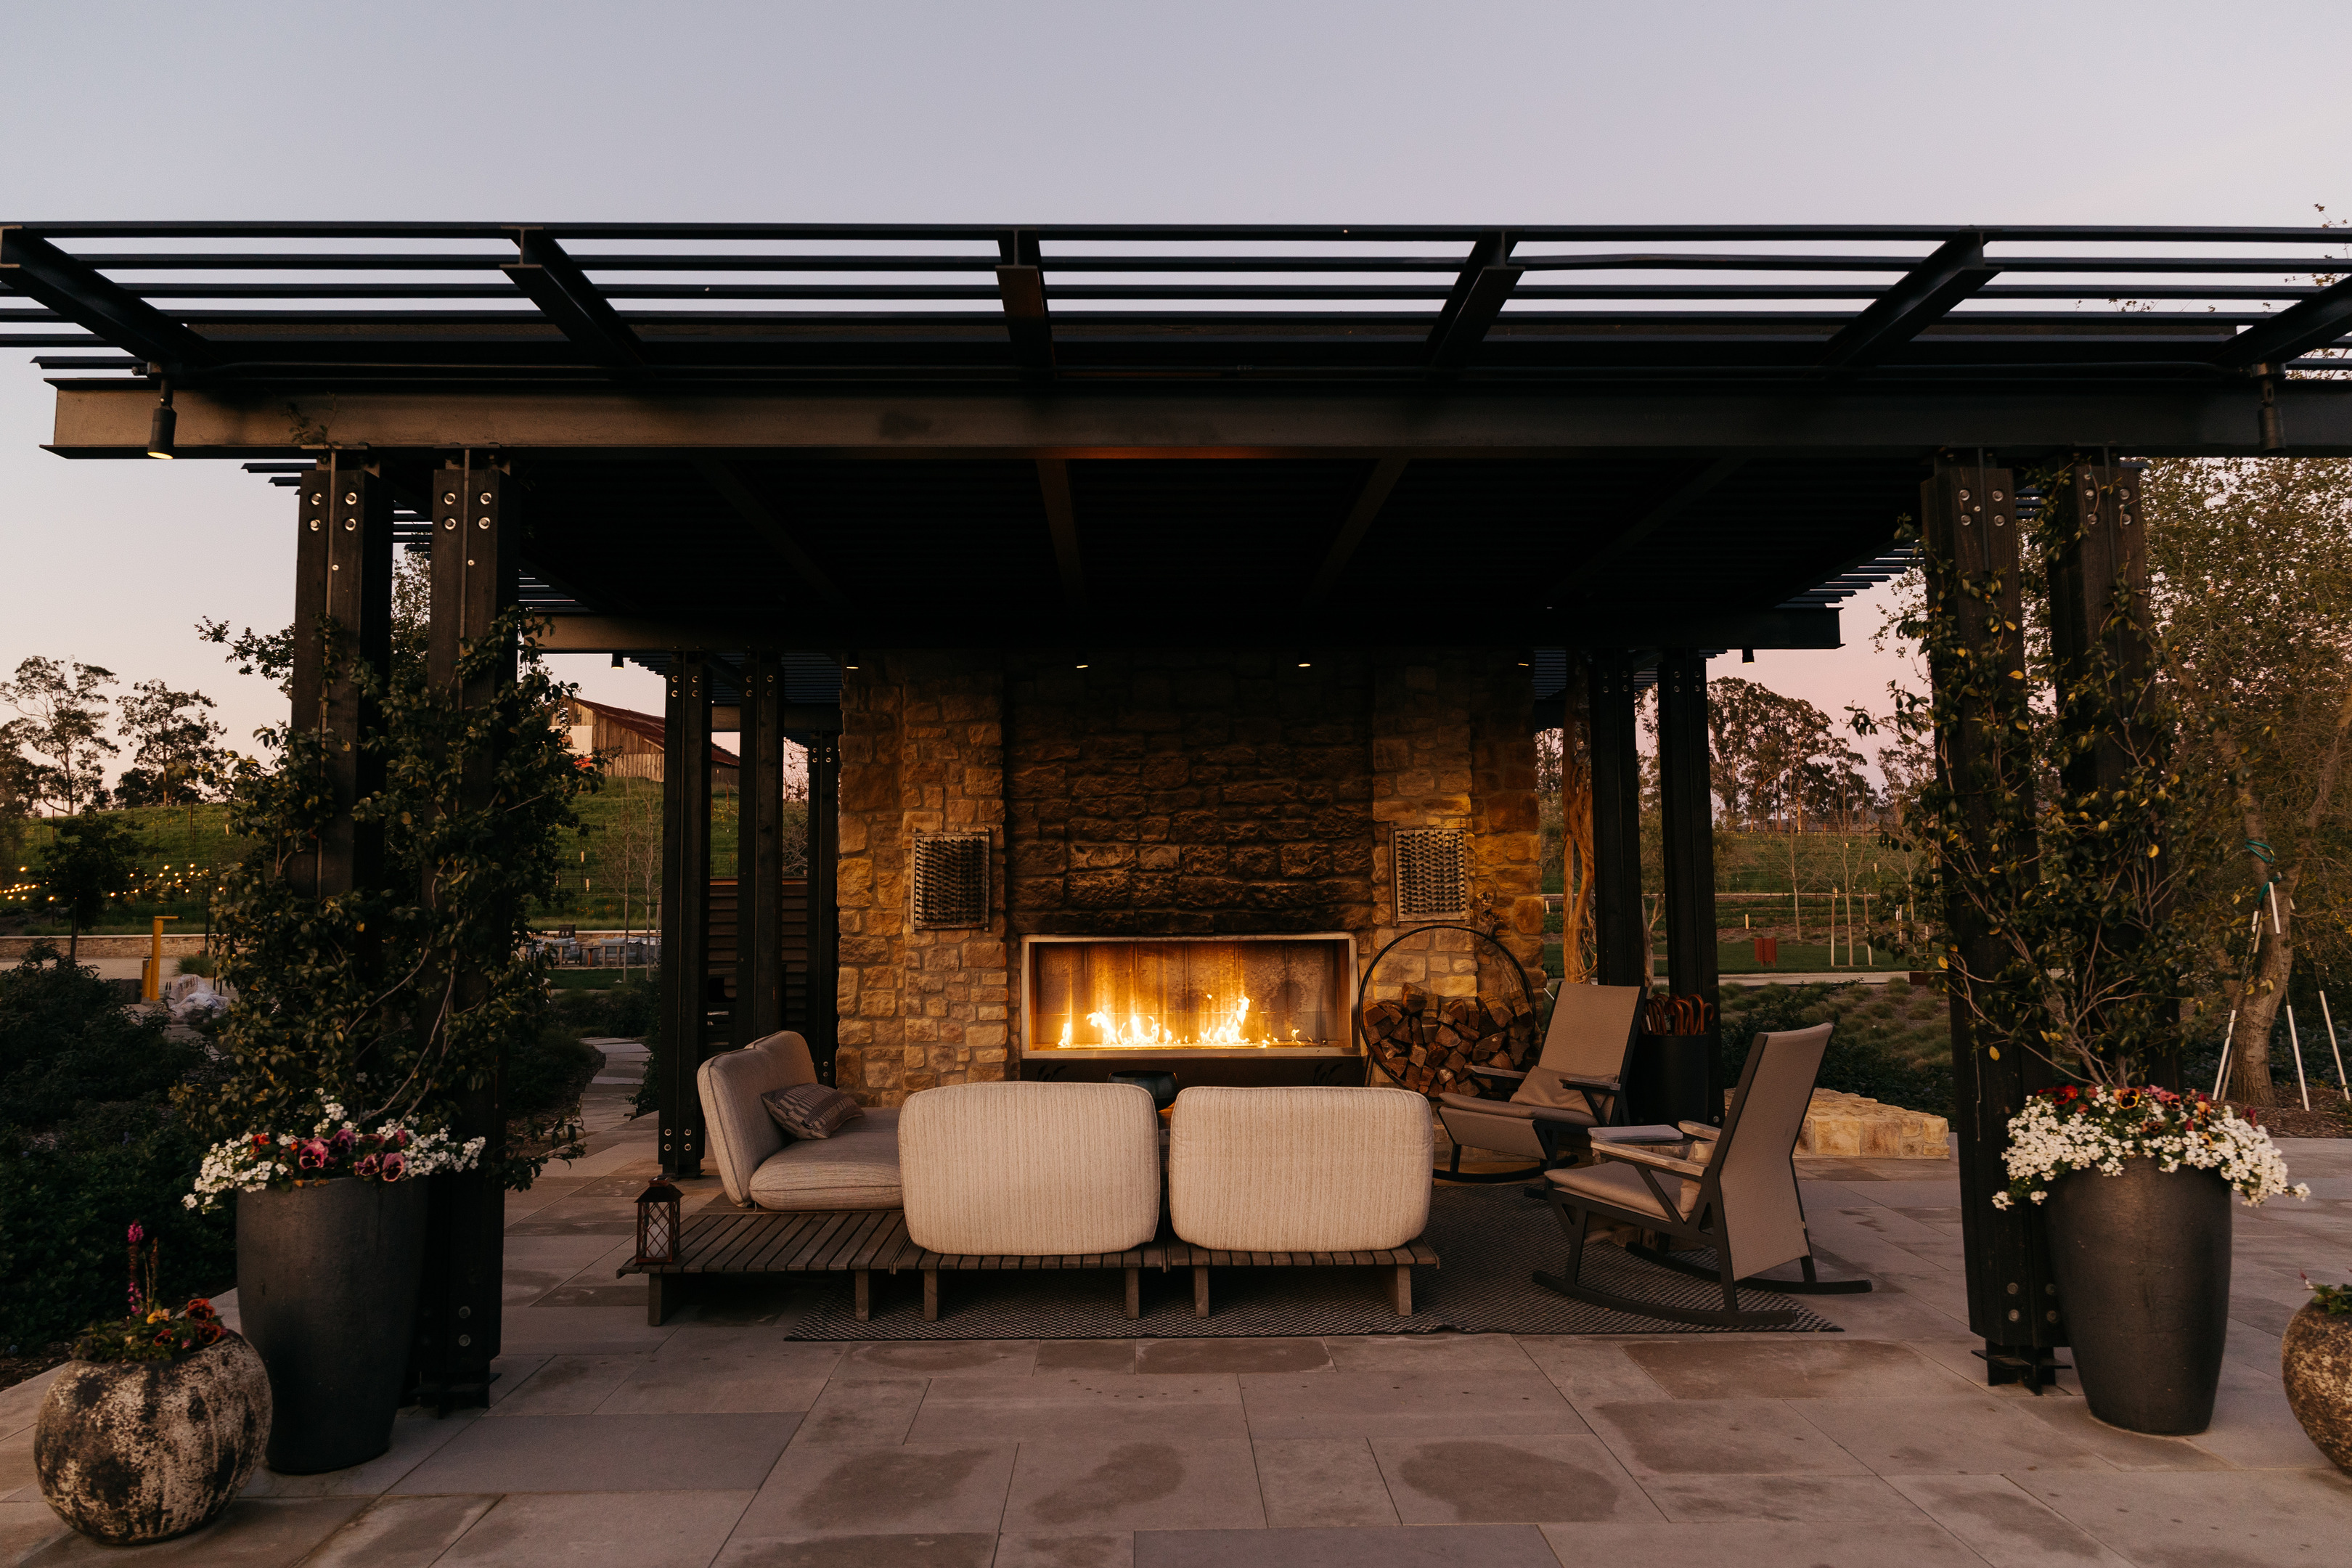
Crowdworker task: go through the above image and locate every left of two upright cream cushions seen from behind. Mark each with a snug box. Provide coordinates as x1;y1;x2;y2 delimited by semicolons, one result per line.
899;1084;1159;1258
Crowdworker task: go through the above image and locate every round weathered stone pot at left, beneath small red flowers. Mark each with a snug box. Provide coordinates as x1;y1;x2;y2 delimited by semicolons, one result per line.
33;1333;271;1547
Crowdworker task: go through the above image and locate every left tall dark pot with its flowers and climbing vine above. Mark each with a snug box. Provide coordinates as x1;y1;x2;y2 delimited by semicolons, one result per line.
184;611;597;1474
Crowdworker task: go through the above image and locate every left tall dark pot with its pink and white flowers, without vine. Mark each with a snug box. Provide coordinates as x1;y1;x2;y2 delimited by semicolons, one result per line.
186;1103;484;1477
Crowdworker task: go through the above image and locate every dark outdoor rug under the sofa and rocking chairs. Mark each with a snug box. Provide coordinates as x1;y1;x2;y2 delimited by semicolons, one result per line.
785;1185;1839;1340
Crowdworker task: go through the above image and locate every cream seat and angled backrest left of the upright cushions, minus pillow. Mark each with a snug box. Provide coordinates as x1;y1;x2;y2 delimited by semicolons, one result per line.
694;1029;898;1211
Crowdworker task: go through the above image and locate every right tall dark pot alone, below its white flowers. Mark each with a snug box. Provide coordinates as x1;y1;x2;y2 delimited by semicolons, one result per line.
2044;1159;2230;1437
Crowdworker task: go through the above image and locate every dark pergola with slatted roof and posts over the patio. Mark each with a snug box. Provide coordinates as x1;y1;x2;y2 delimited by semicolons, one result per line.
18;224;2352;1399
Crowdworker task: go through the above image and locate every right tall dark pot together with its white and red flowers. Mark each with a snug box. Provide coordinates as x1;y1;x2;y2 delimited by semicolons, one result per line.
1992;1084;2312;1434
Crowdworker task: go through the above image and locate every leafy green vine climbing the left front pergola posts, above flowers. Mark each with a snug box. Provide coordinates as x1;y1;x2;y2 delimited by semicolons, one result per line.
190;611;600;1187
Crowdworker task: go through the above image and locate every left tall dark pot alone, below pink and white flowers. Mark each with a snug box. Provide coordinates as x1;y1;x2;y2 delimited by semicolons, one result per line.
237;1177;425;1477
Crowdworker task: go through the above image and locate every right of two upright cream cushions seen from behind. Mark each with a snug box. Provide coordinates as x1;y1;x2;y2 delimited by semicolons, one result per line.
1169;1086;1434;1253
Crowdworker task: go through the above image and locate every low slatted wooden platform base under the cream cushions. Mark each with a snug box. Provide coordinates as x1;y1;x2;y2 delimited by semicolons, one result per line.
616;1209;1437;1328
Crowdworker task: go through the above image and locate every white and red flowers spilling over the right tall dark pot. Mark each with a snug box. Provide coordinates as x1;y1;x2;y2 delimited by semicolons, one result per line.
1992;1084;2312;1209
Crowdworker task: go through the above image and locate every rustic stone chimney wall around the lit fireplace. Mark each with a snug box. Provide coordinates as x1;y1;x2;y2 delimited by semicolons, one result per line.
835;651;1543;1105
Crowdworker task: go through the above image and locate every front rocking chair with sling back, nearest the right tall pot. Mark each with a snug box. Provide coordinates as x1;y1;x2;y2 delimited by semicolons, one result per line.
1536;1023;1870;1328
